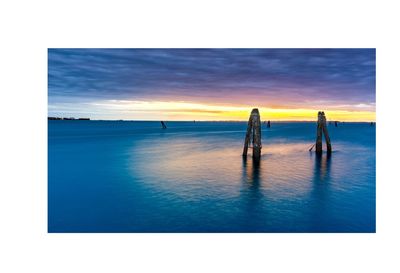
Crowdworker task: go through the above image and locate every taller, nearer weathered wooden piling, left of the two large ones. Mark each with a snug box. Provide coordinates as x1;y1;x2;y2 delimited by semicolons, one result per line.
243;108;262;161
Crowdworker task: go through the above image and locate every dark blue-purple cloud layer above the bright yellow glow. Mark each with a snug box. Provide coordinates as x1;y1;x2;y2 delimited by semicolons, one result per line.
48;49;375;105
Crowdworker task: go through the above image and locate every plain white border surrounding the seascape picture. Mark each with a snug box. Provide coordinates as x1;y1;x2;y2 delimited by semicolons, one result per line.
0;0;400;273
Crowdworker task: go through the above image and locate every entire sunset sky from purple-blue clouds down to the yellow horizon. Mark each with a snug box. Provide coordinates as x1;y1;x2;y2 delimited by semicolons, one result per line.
48;49;375;121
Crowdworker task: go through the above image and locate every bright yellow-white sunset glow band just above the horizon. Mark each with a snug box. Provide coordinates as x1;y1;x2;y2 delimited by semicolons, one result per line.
89;100;376;121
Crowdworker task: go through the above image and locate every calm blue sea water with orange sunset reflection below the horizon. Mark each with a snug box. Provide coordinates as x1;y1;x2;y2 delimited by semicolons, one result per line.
48;120;376;232
